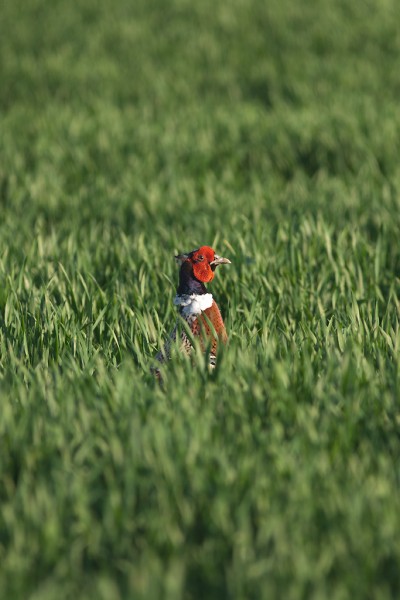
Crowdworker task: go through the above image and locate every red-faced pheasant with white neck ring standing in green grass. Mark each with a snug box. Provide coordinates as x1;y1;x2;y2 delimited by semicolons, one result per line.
154;246;231;378
